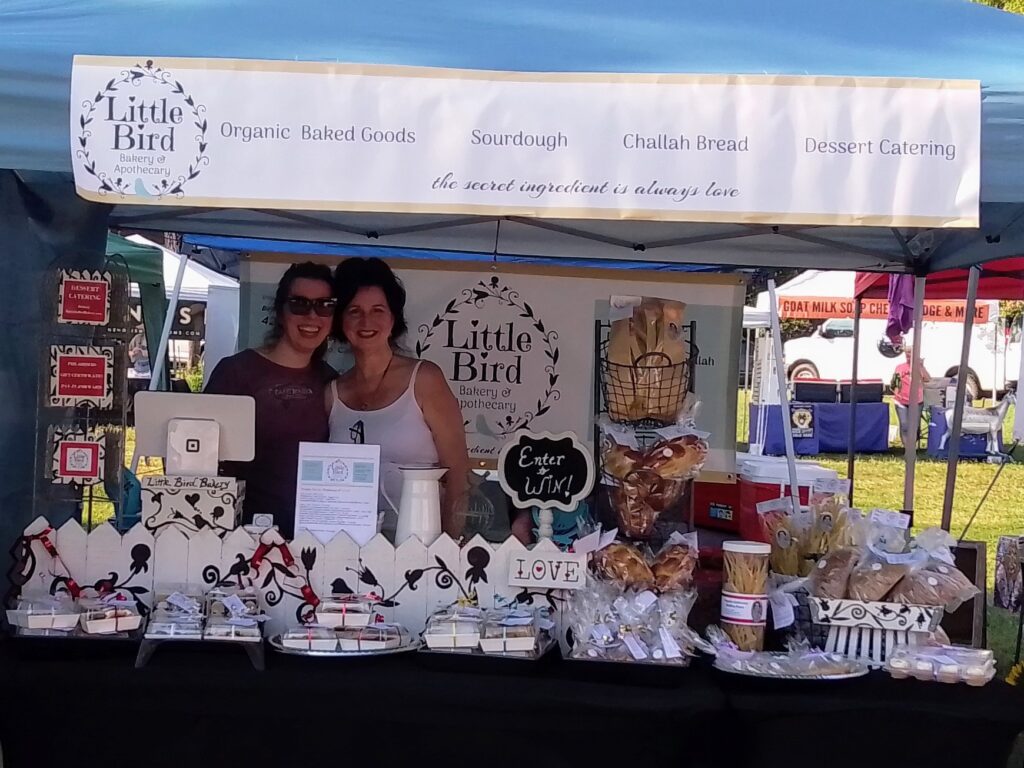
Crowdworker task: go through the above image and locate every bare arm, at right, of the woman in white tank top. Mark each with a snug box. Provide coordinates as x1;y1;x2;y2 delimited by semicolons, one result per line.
415;361;469;539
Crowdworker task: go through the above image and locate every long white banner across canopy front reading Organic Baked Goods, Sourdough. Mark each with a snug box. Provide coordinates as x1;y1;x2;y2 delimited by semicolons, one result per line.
71;56;981;227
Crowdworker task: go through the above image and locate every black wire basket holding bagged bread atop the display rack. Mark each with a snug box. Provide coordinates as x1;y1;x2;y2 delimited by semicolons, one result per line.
599;340;692;427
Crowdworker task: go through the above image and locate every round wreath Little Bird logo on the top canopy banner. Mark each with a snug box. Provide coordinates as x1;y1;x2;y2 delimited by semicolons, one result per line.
75;59;210;199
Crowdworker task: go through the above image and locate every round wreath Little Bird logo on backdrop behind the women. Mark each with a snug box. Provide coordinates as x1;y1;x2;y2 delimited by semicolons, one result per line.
415;275;561;458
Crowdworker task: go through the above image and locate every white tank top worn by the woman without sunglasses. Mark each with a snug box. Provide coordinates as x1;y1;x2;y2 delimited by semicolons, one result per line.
330;360;437;530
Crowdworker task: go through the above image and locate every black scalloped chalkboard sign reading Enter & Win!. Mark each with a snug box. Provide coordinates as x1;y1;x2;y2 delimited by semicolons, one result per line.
498;430;594;512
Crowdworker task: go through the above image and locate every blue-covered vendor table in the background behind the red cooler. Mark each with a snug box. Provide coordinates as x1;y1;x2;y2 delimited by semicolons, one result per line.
748;402;889;456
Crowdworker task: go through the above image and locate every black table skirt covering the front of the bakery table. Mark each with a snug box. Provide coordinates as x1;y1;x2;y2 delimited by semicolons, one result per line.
0;641;1024;768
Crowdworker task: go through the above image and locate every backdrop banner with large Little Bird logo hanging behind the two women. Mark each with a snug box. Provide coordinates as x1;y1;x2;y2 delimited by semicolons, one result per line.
239;259;744;479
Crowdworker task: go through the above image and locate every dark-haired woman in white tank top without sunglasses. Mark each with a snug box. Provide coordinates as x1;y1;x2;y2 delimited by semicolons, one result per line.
325;258;469;539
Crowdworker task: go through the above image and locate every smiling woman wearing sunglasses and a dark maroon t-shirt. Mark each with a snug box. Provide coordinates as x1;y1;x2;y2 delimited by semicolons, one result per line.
206;261;337;539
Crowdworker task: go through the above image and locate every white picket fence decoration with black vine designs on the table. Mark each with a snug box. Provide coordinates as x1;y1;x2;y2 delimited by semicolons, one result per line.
9;517;563;633
